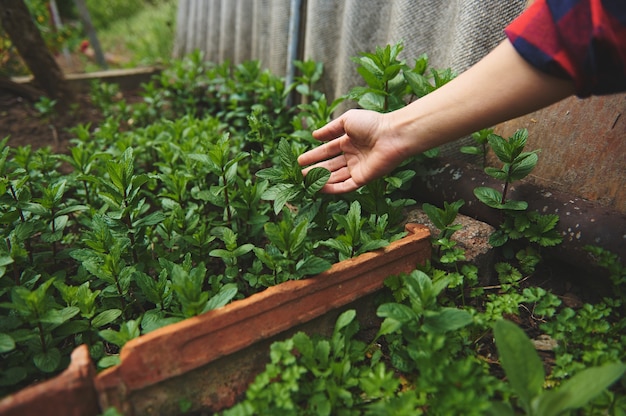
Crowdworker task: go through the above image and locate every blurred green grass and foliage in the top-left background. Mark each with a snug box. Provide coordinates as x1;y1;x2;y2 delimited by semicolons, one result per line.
0;0;178;77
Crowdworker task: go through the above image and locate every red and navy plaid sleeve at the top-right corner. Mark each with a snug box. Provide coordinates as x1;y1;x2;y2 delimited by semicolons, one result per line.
505;0;626;97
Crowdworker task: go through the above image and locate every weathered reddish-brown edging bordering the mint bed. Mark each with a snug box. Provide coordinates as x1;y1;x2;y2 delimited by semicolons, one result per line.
0;224;430;416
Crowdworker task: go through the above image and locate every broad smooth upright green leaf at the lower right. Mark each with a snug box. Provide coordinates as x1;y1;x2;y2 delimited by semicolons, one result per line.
493;320;545;410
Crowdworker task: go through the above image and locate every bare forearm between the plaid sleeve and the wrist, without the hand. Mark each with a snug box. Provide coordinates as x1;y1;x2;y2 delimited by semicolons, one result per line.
387;40;575;154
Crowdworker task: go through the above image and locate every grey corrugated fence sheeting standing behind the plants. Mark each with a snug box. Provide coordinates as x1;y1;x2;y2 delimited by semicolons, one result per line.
174;0;526;98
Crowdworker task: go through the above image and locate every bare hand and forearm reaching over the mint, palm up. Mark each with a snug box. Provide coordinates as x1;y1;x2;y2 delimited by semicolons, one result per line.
298;40;575;194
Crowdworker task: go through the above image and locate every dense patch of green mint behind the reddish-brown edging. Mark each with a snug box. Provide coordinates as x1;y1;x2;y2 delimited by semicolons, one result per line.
0;50;414;393
